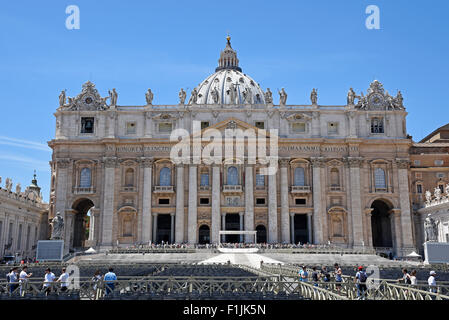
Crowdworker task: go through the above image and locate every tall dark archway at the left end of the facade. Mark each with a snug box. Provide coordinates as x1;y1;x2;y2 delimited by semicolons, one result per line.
72;198;94;248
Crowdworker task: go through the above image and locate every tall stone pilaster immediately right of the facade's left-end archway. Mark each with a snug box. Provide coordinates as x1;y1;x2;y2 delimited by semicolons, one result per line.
102;157;117;247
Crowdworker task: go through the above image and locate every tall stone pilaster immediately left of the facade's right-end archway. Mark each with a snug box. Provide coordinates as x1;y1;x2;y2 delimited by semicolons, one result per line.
348;157;364;247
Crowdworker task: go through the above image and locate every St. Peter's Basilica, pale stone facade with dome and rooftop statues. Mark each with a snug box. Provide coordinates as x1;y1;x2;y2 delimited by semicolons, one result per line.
49;38;414;256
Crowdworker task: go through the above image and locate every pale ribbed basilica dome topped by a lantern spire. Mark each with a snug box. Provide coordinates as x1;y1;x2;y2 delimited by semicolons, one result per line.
189;37;265;105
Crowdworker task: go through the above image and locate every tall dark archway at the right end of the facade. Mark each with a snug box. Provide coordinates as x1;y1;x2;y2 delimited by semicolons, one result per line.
371;200;393;248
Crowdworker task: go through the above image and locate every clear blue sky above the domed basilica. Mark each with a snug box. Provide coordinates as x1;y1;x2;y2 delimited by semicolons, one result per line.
0;0;449;201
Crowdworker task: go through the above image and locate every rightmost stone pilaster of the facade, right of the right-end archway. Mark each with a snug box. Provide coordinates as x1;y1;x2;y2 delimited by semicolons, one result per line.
396;159;415;254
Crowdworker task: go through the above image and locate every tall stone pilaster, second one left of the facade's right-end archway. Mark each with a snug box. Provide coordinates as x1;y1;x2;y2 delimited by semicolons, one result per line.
311;158;326;244
